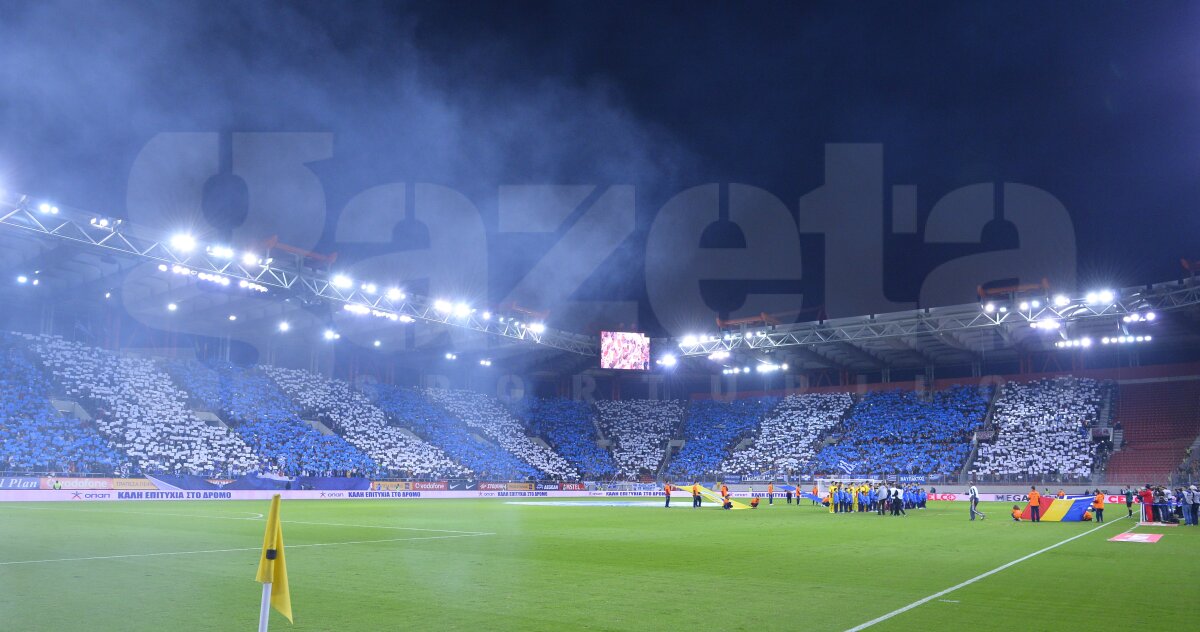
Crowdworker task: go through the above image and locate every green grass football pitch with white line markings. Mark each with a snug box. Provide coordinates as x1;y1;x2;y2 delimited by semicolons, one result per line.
0;499;1200;632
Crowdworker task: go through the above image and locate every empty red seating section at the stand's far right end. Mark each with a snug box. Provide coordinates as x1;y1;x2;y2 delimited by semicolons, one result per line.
1108;379;1200;484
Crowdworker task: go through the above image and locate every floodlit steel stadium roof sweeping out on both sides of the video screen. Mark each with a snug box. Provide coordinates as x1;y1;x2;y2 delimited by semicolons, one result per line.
0;195;1200;371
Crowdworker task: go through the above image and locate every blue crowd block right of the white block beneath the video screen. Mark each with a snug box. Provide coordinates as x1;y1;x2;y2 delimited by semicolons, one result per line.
666;397;779;480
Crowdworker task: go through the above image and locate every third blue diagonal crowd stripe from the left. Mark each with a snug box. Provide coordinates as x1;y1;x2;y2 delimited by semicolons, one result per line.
364;384;538;480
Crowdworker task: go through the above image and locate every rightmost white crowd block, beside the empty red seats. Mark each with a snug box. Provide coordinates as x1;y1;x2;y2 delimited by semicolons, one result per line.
972;378;1108;481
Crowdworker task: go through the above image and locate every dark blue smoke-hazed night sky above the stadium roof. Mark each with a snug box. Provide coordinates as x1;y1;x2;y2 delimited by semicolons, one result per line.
0;1;1200;333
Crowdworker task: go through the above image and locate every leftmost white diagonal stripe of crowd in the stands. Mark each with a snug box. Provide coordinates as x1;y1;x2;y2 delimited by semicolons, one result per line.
28;336;258;475
